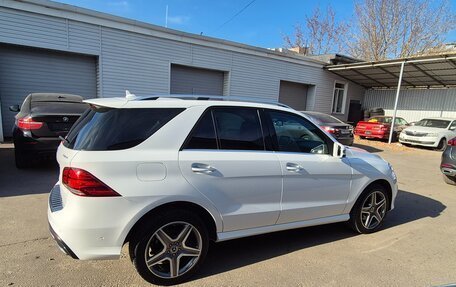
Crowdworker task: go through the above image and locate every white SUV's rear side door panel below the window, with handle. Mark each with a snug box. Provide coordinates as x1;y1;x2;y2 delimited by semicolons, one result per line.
179;150;282;231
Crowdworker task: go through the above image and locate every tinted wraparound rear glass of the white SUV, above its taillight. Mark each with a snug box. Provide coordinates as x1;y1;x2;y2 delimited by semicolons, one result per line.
64;107;184;151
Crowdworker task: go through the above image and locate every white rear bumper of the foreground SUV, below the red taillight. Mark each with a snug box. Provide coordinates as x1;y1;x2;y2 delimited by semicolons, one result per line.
48;184;157;260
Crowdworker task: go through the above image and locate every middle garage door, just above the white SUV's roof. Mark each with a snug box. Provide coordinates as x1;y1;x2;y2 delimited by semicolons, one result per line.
171;65;224;96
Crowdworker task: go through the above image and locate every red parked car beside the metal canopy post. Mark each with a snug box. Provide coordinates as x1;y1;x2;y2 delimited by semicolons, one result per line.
355;116;408;141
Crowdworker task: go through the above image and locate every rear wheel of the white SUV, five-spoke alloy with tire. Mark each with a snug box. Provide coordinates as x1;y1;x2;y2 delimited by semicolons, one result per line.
133;211;209;285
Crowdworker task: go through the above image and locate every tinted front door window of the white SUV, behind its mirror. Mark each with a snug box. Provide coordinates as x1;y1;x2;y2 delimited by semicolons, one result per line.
268;111;328;154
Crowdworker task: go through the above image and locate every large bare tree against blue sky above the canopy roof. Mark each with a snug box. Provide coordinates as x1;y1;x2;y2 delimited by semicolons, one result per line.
346;0;456;60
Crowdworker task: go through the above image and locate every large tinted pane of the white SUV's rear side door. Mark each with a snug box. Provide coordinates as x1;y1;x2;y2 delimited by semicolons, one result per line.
213;107;265;150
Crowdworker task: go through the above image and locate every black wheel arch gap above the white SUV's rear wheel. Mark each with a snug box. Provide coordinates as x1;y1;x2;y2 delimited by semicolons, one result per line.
124;201;217;244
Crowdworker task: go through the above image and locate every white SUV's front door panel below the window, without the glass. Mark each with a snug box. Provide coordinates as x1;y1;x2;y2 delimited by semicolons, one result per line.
277;152;351;223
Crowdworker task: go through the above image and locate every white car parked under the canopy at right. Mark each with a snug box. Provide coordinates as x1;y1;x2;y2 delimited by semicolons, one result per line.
399;118;456;148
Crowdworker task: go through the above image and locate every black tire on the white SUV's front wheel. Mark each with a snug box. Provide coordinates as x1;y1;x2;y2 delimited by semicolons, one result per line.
348;184;390;234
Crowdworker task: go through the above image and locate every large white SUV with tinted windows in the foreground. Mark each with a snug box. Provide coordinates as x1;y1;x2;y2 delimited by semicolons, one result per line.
48;96;397;285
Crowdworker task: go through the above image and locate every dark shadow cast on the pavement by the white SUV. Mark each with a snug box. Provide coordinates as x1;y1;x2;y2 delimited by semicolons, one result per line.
198;191;446;278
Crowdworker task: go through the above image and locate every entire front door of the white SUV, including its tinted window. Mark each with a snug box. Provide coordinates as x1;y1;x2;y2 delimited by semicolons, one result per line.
266;110;352;224
